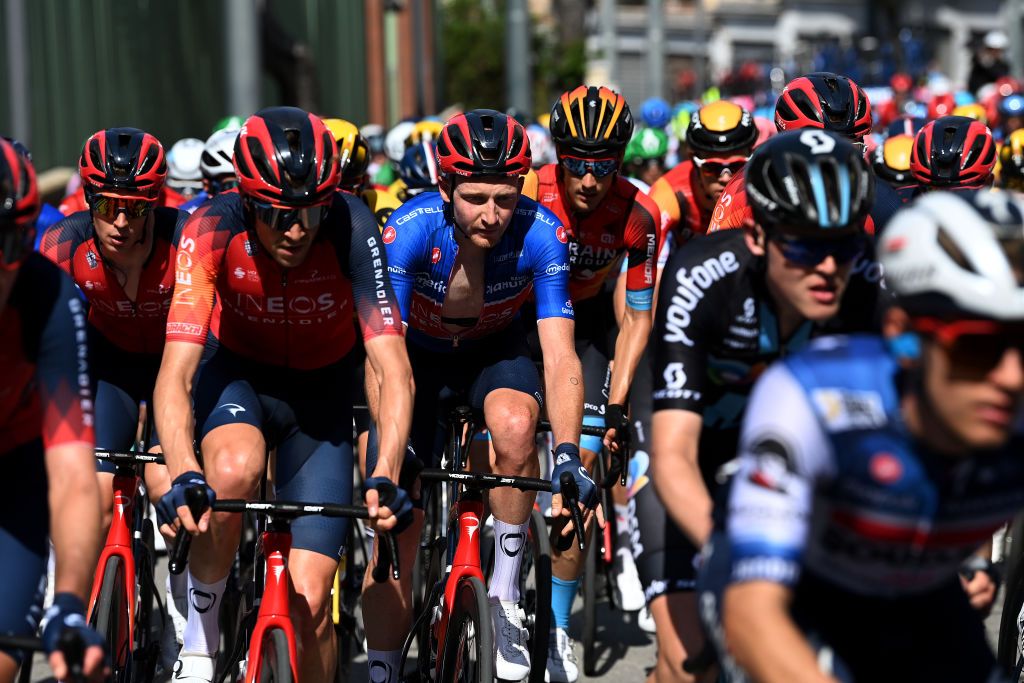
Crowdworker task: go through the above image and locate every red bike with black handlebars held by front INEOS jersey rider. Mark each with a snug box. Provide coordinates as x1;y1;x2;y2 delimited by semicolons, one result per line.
171;487;399;683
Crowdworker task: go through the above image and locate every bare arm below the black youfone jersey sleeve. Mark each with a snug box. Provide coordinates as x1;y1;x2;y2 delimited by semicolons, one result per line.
650;451;712;548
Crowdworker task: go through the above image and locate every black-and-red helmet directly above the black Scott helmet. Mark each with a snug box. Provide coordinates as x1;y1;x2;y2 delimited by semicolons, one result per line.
775;72;871;141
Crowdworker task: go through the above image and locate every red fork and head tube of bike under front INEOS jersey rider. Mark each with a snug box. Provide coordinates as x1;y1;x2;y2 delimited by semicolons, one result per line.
246;524;299;683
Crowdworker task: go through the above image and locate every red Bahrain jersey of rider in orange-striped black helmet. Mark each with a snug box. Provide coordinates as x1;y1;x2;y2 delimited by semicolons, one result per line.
537;164;662;310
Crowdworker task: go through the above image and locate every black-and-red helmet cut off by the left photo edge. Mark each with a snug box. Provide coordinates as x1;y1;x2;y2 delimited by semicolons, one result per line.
0;139;41;267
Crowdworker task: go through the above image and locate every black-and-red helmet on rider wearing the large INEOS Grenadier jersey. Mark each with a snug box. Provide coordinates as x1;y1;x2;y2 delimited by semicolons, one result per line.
233;106;341;208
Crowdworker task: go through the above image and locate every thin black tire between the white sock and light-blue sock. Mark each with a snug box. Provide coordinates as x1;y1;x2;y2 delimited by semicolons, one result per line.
520;508;551;683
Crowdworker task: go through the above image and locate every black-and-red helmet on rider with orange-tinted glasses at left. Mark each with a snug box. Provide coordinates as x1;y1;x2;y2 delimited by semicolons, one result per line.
78;128;167;201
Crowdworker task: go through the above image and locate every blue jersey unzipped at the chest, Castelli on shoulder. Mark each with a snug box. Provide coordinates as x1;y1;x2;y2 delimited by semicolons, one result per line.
382;193;572;351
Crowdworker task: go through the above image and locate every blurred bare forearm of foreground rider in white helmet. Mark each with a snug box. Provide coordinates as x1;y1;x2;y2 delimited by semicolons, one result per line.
723;586;835;683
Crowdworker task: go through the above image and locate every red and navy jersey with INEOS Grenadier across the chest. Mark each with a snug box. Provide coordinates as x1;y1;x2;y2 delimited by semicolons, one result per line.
167;193;402;370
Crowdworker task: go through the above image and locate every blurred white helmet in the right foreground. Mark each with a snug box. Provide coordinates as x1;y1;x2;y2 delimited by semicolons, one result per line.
878;191;1024;322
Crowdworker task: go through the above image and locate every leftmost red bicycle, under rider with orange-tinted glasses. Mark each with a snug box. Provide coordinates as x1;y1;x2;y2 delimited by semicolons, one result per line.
86;450;164;683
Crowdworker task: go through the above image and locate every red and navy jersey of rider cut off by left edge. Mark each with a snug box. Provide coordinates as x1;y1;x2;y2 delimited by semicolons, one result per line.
0;254;93;454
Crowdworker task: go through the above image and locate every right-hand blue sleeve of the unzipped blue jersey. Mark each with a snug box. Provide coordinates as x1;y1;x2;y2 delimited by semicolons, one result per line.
523;205;573;321
